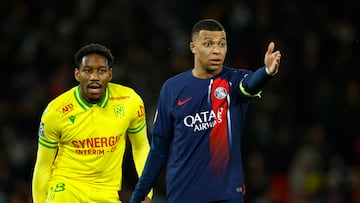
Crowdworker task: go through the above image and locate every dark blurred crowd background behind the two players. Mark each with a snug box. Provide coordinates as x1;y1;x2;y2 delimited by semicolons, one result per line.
0;0;360;203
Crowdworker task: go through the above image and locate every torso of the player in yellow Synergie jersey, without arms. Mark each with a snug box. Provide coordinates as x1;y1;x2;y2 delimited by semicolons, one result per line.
45;84;138;185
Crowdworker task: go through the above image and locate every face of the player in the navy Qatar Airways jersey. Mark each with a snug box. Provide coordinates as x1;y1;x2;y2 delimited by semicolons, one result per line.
190;30;227;72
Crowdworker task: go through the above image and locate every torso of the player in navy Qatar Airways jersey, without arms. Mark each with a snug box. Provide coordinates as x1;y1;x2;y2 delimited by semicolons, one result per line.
162;68;248;200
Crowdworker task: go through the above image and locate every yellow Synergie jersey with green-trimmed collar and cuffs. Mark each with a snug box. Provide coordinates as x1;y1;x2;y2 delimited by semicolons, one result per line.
33;83;150;201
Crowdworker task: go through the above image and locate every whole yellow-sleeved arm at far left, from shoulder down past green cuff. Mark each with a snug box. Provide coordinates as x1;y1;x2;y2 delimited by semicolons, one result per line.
32;107;59;203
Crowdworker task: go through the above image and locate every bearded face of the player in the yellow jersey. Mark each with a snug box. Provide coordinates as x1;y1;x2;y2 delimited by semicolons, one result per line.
75;54;112;104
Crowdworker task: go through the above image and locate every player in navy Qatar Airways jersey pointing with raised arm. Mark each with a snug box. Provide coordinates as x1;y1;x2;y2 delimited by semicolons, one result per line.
131;19;281;203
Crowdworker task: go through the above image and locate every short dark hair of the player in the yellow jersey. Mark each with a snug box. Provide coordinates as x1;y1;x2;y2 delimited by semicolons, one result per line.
74;43;114;67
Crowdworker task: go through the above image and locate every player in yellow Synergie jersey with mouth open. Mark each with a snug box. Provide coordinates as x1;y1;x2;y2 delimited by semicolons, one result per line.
32;44;152;203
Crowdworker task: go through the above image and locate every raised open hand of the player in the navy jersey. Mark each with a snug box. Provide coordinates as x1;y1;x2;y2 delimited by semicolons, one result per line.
264;42;281;75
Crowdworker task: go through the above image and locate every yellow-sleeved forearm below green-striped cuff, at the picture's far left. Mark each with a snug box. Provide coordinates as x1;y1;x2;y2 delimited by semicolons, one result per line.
32;145;56;203
